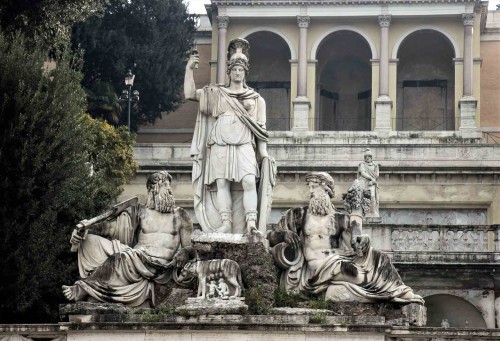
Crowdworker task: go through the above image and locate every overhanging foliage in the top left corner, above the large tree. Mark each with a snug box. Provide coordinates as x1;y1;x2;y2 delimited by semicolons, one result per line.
0;0;104;54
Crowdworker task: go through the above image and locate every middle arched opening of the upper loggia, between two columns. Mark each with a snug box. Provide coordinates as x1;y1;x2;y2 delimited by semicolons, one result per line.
315;30;372;131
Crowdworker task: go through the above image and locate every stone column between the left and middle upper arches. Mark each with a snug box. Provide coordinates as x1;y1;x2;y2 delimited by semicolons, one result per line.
292;15;311;131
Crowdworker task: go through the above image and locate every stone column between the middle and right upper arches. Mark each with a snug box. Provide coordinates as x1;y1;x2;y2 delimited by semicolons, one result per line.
374;14;392;133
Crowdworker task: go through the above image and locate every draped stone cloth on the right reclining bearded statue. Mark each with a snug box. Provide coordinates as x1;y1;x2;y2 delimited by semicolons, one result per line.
268;207;423;304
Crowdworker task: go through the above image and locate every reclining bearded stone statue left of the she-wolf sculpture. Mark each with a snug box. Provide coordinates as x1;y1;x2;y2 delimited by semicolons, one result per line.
63;171;193;307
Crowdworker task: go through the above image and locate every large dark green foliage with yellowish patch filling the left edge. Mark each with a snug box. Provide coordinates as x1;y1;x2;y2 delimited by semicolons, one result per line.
0;32;136;323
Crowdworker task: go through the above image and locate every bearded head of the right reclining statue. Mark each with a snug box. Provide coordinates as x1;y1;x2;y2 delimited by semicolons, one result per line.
306;172;335;216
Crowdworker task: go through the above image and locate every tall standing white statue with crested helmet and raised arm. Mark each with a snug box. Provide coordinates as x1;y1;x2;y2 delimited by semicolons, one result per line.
184;38;276;234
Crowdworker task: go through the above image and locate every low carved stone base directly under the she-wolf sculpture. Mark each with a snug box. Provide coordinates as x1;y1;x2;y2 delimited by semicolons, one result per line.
175;297;248;316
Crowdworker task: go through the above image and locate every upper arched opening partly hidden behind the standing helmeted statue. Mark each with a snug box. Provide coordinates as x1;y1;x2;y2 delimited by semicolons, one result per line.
245;31;291;130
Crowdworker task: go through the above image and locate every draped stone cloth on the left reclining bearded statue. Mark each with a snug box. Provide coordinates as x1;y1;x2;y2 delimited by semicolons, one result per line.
75;205;180;307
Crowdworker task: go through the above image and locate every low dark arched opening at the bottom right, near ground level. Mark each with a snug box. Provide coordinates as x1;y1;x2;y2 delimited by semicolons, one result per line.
425;294;486;328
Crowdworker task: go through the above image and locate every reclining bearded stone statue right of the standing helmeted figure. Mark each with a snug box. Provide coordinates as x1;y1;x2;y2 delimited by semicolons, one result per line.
268;172;423;304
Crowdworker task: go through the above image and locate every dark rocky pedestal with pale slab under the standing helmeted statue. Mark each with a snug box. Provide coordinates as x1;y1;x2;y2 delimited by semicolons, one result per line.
191;233;278;314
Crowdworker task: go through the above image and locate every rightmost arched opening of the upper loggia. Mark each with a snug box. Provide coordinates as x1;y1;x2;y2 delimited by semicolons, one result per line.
396;29;456;130
